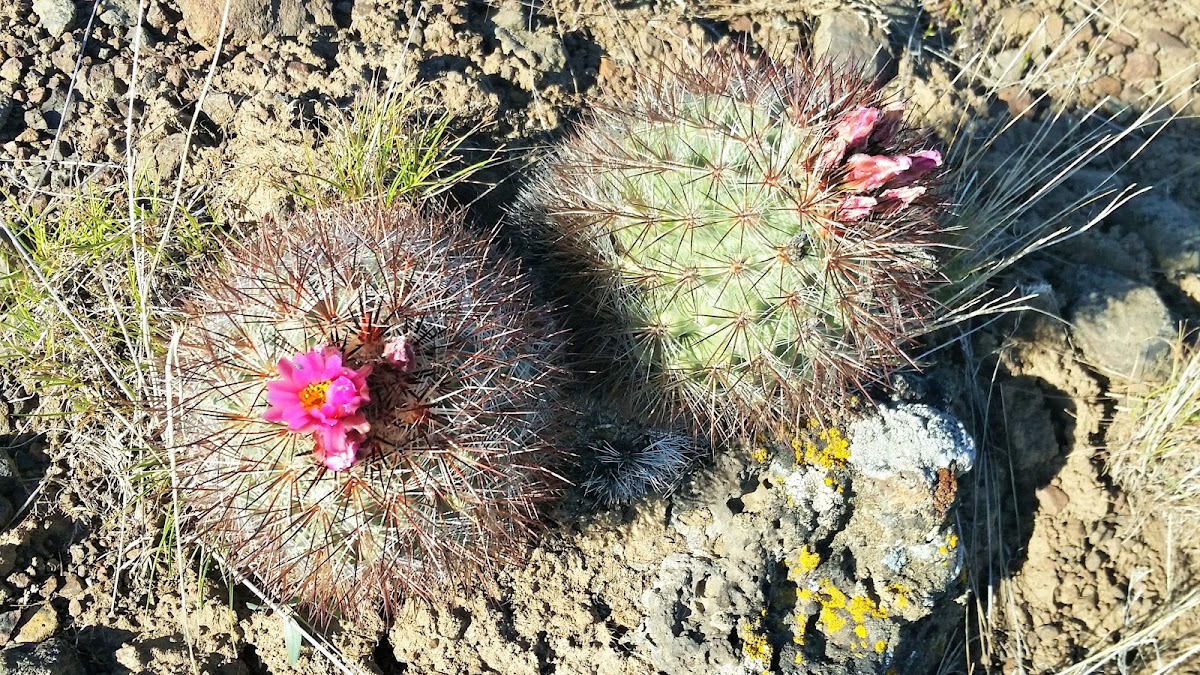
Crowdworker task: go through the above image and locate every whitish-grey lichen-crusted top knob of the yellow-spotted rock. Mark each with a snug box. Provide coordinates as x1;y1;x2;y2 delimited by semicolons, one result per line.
847;404;976;483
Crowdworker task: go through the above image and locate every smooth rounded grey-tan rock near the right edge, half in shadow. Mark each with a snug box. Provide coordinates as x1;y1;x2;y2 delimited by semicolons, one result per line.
1070;268;1176;380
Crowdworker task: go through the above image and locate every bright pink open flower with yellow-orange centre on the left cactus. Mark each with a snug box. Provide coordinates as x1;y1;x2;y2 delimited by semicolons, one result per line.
263;347;371;471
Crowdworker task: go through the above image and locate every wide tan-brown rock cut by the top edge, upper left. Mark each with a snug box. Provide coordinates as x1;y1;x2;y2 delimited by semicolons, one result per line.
179;0;335;47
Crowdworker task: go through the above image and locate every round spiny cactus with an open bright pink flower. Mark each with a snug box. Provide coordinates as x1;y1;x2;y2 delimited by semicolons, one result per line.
178;200;564;619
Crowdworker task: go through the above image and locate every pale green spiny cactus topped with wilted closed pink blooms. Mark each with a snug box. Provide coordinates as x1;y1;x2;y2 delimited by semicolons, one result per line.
515;52;942;440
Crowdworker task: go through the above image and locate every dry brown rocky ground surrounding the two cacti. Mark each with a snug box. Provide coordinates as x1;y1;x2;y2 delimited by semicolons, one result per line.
0;0;1200;674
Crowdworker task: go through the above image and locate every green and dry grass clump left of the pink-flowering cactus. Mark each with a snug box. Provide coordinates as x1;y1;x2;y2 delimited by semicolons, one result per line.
0;185;216;487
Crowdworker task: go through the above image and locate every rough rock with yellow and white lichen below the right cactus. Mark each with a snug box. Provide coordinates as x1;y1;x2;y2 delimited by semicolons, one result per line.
638;404;974;675
